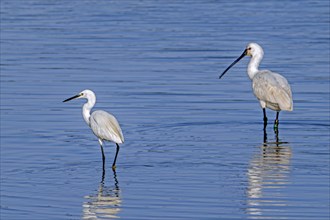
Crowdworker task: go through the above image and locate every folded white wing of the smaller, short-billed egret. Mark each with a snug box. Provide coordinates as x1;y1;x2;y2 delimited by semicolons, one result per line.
90;110;124;143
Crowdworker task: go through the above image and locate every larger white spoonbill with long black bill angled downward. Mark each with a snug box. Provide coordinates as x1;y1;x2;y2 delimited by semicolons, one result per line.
219;43;293;130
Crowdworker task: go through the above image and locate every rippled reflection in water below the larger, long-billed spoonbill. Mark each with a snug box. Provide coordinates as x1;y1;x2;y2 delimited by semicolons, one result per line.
247;129;291;219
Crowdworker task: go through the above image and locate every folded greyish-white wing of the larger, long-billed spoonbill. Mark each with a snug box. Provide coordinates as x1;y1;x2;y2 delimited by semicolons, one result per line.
252;70;293;111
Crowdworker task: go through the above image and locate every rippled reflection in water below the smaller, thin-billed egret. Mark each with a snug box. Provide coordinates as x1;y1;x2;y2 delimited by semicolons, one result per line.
82;171;121;220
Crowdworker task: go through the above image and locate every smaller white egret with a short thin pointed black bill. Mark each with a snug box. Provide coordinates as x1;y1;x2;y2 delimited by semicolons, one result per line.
63;89;124;171
